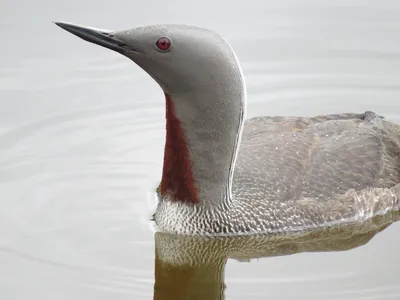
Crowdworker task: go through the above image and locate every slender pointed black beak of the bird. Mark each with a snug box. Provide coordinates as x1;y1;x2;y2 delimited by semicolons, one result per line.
54;22;130;54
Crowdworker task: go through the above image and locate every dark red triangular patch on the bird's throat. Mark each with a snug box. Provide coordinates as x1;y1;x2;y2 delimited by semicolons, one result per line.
160;95;200;204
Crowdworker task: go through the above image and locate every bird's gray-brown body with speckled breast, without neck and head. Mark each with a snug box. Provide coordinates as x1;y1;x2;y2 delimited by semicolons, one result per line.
158;112;400;234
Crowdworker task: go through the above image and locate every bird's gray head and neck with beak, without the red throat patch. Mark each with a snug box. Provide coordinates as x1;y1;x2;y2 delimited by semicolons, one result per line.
56;23;245;209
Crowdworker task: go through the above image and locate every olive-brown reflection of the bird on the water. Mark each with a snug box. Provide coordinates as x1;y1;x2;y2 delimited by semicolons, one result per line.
154;212;400;300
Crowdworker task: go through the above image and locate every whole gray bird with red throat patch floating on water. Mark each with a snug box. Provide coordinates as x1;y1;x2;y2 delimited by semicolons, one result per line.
55;22;400;236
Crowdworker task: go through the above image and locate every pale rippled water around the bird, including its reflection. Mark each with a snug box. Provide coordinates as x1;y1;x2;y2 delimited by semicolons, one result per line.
0;0;400;300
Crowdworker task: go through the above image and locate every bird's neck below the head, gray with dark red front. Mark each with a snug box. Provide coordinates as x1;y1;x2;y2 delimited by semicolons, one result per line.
160;91;245;207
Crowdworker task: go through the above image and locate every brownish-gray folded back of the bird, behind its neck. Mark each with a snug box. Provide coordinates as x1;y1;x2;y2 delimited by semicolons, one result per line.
233;112;400;202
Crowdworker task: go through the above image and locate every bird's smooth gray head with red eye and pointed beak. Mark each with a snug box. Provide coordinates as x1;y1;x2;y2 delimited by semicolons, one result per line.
56;23;245;94
